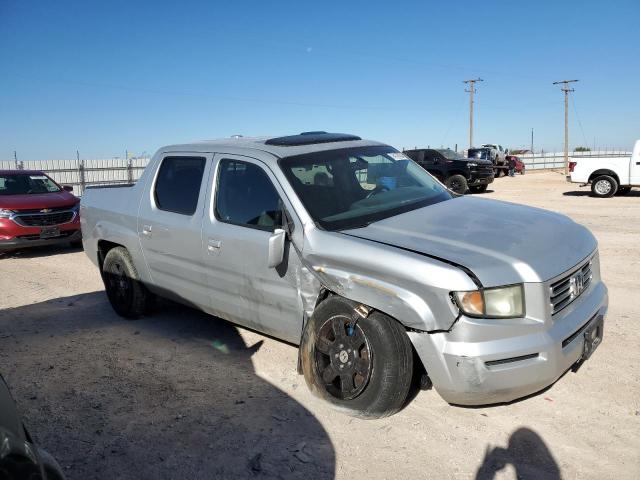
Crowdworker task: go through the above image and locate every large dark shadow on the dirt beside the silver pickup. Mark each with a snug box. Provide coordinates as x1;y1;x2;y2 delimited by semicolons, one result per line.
0;292;335;479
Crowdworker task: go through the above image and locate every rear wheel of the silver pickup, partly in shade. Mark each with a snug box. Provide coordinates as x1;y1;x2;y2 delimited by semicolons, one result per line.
102;247;151;319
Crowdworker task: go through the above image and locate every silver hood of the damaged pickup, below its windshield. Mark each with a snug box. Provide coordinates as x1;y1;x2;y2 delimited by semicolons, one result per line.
342;196;597;287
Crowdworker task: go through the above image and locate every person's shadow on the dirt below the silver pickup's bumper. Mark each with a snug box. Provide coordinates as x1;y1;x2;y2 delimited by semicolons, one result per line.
475;427;561;480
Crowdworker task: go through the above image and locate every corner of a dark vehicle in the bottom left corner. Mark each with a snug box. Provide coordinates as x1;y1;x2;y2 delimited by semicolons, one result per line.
0;375;64;480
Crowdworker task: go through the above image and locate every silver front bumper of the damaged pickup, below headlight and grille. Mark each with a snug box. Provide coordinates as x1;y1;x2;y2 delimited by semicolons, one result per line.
409;282;608;405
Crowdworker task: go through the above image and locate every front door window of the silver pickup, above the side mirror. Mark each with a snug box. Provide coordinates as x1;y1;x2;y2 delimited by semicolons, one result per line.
215;159;282;232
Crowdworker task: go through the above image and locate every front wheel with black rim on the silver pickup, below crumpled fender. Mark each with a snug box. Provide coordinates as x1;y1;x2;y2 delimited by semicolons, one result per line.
300;296;413;418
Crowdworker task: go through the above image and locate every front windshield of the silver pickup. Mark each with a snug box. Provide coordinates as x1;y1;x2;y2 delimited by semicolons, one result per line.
280;146;453;230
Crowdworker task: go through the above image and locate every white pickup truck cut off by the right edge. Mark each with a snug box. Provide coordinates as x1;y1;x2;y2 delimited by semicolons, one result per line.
567;140;640;198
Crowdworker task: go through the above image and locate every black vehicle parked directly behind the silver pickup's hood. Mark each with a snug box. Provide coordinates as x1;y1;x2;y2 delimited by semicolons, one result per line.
404;148;493;193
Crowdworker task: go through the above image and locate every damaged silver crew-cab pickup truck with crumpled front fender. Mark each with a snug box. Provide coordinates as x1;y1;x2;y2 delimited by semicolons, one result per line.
80;132;608;417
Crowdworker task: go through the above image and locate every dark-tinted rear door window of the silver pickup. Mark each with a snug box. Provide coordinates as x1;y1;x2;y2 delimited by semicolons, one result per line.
154;157;206;215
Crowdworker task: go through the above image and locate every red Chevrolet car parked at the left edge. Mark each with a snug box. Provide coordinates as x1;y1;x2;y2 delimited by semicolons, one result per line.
0;170;82;251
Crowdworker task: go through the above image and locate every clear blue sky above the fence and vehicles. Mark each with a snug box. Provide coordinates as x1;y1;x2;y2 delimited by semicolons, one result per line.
0;0;640;160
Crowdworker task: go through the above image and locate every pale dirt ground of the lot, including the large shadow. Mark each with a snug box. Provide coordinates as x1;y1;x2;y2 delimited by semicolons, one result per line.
0;172;640;480
